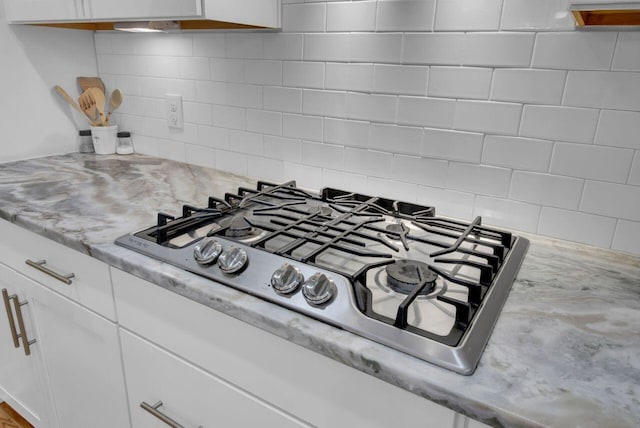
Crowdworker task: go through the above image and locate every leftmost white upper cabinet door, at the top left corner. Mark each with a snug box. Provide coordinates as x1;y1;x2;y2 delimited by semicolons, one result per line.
4;0;85;22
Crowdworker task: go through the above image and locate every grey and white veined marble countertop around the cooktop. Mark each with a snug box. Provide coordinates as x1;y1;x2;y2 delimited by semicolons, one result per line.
0;153;640;427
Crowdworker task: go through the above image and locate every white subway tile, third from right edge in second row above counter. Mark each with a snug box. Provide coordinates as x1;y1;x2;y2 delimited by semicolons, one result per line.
447;162;511;198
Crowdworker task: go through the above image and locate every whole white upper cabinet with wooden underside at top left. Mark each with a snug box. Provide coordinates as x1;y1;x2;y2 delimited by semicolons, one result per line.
4;0;281;30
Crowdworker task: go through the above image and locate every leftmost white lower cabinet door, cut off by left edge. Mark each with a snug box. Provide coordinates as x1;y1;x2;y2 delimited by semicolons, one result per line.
0;264;54;427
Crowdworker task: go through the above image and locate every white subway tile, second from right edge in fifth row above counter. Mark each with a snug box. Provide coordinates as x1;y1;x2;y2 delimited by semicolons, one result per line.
491;69;566;105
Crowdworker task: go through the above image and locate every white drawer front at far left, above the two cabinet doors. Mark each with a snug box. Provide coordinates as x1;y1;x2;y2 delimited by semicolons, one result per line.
0;220;115;321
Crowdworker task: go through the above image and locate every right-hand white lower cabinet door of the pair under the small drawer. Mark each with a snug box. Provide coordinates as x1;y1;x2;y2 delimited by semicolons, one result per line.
30;281;129;428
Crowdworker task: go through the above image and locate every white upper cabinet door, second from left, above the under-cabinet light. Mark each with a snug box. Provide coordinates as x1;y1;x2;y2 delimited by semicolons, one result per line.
86;0;202;21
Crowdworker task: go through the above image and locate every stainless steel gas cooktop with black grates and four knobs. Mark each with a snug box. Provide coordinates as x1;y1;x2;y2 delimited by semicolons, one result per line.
116;181;529;374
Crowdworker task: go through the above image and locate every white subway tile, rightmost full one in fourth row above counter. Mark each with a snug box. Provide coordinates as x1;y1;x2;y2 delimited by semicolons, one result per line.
520;105;598;144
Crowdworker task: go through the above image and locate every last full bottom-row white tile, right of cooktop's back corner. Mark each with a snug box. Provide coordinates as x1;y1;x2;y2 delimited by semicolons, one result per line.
538;207;616;247
